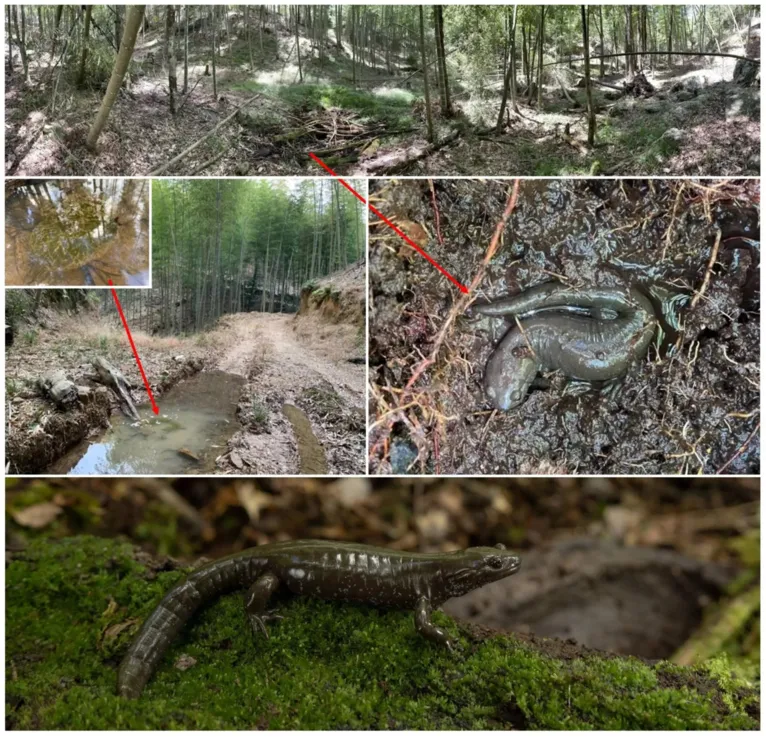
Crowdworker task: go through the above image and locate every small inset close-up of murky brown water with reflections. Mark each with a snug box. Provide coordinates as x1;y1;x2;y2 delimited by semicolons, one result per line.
5;178;150;286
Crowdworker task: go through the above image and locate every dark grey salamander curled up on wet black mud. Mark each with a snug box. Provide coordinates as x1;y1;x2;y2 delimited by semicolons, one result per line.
473;282;657;411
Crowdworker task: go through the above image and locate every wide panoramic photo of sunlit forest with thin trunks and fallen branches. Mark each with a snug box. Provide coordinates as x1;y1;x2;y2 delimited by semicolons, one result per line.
5;4;760;176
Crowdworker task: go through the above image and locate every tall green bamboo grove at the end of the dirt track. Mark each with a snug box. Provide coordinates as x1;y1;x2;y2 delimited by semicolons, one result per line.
109;179;366;335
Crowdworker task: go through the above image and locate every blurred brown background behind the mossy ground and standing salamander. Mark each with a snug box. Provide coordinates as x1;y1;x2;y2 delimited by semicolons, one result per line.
6;477;760;679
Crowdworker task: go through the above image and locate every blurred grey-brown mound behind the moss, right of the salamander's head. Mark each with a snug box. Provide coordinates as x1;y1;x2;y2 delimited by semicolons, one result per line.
444;538;736;660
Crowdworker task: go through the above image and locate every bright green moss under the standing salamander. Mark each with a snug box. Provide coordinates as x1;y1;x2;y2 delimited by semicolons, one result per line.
6;537;758;729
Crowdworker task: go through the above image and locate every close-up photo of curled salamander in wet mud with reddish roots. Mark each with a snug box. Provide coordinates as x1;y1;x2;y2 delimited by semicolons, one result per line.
369;179;761;475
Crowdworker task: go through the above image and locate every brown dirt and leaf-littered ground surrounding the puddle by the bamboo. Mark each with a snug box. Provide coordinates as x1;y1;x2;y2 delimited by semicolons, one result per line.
5;265;366;474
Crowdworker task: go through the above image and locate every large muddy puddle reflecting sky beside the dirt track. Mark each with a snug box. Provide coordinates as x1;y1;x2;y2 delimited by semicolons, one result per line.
48;371;244;474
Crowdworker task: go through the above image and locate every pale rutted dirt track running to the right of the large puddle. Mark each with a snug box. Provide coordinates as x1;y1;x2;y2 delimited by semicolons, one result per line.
210;312;365;474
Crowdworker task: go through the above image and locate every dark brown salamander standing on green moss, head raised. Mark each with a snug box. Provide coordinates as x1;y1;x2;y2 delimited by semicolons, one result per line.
117;540;520;698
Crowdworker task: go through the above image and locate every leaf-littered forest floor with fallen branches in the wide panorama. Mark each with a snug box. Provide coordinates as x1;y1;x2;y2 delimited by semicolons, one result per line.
5;16;760;176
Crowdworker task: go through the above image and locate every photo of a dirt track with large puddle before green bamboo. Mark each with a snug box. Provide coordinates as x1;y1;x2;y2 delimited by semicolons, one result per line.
5;179;366;475
